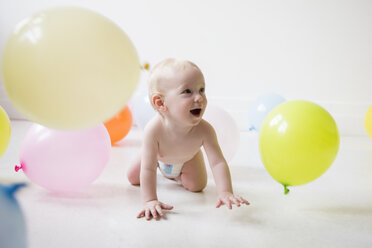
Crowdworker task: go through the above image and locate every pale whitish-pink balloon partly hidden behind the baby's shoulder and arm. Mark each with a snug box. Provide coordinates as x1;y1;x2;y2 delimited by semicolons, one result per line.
203;105;240;161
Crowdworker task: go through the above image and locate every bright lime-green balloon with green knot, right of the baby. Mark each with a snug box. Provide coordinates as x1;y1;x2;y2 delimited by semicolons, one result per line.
259;100;340;193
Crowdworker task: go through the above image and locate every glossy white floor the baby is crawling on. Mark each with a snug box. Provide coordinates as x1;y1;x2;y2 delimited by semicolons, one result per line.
0;121;372;248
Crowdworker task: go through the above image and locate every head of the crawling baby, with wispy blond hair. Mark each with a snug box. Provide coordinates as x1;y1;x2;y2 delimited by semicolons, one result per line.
148;58;207;123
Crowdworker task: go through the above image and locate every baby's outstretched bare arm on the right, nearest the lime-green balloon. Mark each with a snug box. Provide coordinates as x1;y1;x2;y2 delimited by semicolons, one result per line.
201;122;249;209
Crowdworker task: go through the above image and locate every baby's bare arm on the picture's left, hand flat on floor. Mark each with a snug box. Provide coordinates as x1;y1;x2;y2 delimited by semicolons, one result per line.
137;128;173;220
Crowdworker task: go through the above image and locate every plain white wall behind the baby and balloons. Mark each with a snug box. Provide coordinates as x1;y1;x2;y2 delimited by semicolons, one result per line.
0;0;372;135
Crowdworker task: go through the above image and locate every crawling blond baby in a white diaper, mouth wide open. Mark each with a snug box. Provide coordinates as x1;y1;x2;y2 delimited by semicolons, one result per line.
127;59;249;220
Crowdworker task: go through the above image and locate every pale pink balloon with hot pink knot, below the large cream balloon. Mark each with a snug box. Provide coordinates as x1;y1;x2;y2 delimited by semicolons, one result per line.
16;124;111;192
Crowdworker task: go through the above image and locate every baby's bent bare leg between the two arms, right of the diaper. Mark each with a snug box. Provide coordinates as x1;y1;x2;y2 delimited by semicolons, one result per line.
179;150;207;192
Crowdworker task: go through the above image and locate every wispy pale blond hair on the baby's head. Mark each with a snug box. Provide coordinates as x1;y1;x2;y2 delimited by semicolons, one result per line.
148;58;202;103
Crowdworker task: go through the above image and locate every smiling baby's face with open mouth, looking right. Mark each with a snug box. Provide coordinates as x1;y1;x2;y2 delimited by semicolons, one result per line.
163;67;207;125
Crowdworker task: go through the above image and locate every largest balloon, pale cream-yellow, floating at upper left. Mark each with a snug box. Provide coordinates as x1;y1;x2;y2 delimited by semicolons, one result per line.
2;7;140;129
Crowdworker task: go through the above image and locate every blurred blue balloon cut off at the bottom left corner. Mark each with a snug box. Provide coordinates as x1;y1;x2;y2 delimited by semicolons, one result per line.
0;184;27;248
